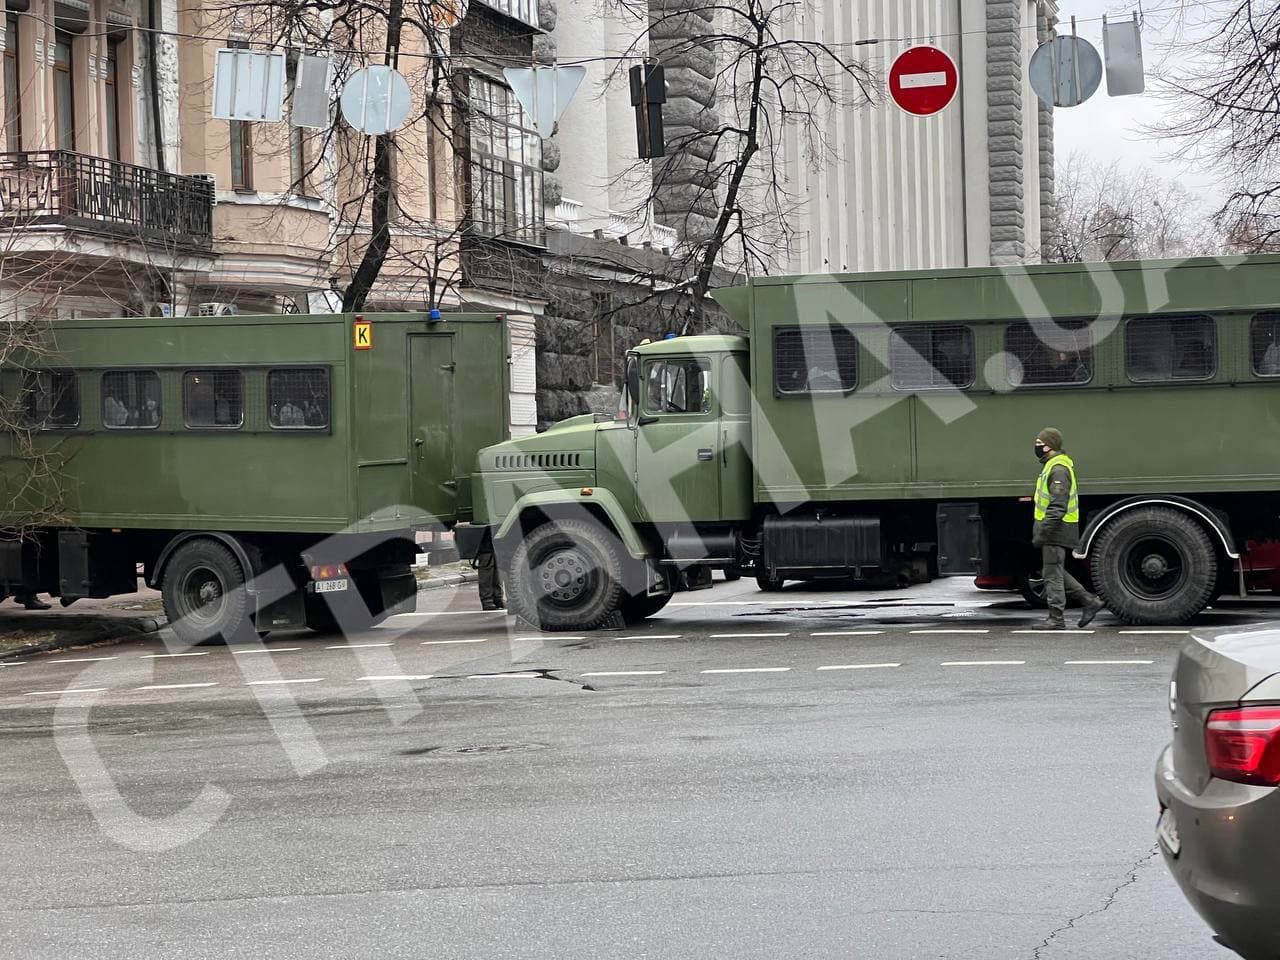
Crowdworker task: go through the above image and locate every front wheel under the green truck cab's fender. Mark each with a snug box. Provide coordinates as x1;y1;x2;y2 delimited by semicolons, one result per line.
507;520;625;630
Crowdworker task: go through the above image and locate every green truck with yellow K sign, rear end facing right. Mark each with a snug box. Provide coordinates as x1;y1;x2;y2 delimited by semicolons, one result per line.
0;311;508;641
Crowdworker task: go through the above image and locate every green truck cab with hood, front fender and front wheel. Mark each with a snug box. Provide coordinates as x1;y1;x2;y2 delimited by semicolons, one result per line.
460;337;753;630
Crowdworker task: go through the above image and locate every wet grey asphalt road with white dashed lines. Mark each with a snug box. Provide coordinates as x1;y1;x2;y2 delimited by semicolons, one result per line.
0;581;1271;960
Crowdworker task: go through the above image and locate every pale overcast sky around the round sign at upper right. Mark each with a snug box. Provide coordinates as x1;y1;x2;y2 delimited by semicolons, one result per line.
1055;0;1220;204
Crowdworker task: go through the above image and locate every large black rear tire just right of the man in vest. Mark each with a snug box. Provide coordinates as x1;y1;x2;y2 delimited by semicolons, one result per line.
1091;507;1219;625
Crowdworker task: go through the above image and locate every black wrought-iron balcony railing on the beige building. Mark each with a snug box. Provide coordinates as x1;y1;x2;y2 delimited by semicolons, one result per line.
0;150;214;251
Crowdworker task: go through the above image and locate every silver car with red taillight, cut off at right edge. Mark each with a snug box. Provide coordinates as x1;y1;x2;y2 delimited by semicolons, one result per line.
1156;623;1280;960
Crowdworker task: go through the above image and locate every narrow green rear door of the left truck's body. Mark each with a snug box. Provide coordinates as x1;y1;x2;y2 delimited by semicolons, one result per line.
408;334;458;527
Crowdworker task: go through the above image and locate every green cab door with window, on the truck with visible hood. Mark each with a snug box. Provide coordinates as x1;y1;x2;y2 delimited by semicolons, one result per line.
636;356;722;524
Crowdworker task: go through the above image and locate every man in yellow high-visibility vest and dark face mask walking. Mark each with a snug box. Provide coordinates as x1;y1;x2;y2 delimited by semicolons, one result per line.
1032;426;1105;630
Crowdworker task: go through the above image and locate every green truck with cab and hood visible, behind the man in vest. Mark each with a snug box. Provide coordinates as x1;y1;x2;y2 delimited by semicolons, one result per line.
463;256;1280;630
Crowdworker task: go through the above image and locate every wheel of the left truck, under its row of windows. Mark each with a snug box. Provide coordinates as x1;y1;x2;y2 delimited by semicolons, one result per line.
160;540;250;644
